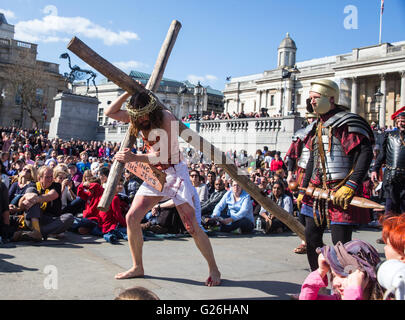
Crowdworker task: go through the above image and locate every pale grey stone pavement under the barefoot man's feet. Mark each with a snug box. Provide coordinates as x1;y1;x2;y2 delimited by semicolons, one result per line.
0;228;384;300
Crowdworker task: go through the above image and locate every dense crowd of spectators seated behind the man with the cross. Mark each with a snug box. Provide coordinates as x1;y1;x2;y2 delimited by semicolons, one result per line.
0;127;379;243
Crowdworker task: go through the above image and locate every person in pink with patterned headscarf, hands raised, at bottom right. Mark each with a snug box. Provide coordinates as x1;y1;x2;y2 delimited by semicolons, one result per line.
299;240;383;300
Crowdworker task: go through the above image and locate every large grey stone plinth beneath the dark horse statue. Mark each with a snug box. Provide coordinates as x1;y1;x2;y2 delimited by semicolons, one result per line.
48;92;99;141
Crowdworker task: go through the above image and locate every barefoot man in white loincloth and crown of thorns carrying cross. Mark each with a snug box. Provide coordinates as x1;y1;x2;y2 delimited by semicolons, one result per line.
105;86;221;286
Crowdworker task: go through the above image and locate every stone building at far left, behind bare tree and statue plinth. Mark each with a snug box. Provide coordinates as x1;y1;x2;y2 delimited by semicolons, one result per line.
0;13;66;129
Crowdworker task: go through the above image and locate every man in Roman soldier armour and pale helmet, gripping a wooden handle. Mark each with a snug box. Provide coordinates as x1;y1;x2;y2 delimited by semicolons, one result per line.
297;80;374;270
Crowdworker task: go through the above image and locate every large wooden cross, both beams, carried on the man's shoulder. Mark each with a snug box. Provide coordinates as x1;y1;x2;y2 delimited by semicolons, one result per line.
68;20;305;240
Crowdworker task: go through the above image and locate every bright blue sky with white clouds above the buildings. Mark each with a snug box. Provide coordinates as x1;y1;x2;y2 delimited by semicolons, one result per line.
0;0;405;90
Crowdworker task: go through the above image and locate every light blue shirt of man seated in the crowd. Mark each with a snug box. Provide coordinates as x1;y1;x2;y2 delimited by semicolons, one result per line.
211;190;254;223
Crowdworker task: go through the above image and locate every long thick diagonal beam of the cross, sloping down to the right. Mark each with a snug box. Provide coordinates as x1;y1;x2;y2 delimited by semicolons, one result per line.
68;26;305;240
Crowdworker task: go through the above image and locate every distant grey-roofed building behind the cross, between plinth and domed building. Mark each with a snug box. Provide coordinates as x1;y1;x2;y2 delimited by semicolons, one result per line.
73;71;223;125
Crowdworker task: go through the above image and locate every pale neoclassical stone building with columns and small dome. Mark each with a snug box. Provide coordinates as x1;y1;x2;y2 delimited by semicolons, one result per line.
224;33;405;126
